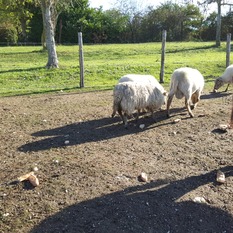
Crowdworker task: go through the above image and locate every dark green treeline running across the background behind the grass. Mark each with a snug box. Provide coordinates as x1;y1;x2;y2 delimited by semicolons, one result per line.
0;0;233;44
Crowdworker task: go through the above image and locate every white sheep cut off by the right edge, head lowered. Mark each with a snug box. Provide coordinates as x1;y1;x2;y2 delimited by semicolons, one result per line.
213;65;233;92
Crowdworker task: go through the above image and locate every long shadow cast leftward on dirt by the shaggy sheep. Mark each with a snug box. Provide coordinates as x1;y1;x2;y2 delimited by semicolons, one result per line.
18;111;169;152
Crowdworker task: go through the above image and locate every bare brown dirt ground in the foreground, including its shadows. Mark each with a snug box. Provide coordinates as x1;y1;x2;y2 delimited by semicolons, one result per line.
0;87;233;233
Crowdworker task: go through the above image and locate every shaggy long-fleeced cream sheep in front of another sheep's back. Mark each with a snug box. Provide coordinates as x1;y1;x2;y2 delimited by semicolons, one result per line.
112;81;166;127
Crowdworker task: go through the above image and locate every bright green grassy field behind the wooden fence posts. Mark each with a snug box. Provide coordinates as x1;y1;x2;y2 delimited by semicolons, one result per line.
0;42;229;96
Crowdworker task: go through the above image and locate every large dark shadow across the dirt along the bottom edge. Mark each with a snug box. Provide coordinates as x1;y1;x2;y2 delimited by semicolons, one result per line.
30;166;233;233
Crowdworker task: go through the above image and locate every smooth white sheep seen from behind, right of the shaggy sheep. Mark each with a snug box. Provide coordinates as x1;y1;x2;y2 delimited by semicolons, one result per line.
167;67;204;117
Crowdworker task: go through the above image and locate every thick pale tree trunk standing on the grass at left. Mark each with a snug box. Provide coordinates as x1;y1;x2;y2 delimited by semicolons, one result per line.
41;0;58;68
